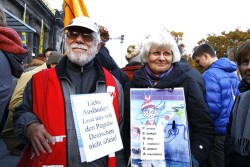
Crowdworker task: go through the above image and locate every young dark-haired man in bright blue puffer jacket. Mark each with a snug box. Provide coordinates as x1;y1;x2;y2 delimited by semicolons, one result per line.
193;44;239;167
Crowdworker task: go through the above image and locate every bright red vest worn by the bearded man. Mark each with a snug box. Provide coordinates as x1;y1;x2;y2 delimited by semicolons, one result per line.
18;68;119;167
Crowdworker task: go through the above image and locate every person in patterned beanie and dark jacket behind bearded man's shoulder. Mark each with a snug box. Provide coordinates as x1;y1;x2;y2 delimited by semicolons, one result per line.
96;25;127;87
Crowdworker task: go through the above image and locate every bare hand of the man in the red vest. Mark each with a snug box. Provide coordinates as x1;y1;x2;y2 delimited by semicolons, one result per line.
26;122;55;156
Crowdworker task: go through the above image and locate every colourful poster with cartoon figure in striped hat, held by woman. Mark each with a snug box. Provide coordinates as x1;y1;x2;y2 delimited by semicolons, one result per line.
130;88;191;167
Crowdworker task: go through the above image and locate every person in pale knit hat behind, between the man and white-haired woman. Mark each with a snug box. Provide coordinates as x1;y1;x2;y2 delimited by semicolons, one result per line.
122;45;142;81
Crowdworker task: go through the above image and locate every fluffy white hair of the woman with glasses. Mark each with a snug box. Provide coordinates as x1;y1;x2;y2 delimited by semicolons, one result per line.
140;30;181;63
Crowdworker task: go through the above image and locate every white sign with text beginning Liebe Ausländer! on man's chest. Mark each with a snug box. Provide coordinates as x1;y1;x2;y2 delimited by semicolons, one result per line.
70;93;123;162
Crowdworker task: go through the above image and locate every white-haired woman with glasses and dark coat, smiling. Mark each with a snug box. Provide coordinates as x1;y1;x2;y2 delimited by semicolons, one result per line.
123;31;214;167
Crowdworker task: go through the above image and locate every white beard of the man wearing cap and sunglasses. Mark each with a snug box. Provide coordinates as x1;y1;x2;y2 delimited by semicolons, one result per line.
66;43;97;66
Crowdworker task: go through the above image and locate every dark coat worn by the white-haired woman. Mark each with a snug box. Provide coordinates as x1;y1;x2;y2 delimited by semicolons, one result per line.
123;63;214;164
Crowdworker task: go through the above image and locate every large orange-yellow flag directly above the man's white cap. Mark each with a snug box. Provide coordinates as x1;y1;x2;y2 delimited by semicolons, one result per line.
63;0;89;27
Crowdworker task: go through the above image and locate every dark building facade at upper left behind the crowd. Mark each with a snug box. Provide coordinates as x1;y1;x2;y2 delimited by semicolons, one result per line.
0;0;63;63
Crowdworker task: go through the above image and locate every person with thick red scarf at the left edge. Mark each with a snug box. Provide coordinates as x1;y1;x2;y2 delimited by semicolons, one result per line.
0;6;28;127
